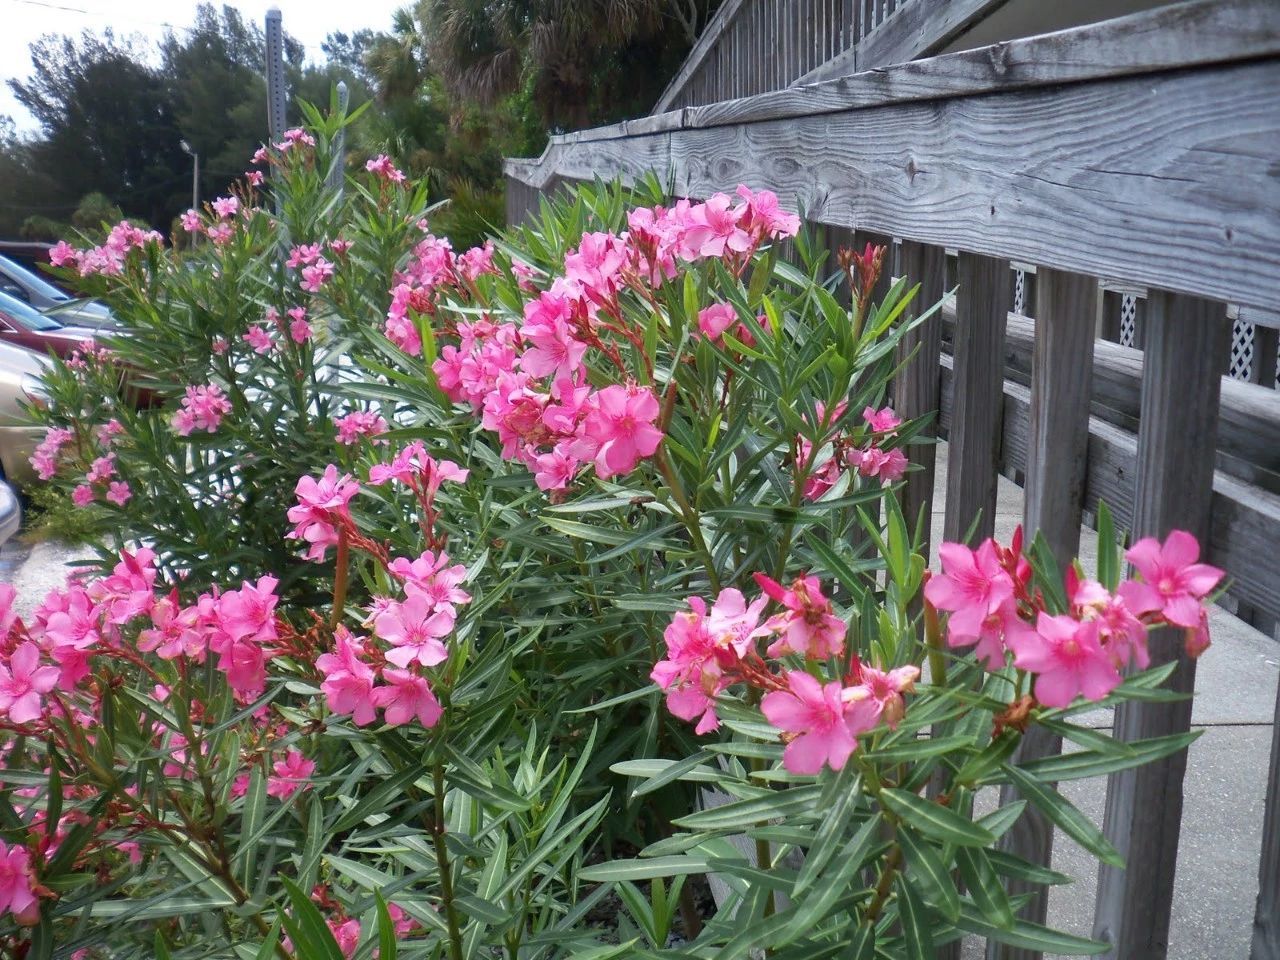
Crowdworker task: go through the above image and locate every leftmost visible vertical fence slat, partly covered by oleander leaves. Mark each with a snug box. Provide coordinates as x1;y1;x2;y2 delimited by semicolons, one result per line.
893;241;946;570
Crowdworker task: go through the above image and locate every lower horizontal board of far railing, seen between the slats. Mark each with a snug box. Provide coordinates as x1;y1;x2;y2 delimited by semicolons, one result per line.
940;358;1280;617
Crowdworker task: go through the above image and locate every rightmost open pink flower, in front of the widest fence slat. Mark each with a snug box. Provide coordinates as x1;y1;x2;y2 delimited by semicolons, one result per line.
1120;530;1222;628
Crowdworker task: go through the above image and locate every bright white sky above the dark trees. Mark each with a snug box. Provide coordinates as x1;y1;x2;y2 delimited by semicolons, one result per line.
0;0;407;132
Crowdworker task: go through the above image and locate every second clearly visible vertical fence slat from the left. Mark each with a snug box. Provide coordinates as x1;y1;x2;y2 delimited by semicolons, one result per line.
943;252;1012;541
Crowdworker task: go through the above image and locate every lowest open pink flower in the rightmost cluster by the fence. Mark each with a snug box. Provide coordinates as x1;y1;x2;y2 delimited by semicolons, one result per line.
1014;613;1120;707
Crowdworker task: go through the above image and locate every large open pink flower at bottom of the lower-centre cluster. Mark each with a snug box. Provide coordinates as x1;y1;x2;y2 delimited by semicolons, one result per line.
760;669;858;776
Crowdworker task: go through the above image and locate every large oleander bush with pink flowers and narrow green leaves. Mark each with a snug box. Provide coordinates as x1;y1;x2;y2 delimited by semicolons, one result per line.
0;108;1221;960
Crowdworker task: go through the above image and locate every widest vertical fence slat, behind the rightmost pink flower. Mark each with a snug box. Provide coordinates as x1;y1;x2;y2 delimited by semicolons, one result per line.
1093;291;1230;960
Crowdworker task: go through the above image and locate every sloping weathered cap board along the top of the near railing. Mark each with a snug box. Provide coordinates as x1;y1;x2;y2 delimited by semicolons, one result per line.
732;0;1280;127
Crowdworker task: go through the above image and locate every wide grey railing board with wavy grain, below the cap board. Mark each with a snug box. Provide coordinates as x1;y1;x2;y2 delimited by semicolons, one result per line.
504;52;1280;312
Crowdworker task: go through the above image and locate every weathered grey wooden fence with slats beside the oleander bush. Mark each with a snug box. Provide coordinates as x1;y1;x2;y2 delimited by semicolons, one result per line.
506;0;1280;960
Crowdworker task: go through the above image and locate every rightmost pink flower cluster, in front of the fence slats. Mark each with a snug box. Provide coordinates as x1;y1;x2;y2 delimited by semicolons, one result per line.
924;530;1222;707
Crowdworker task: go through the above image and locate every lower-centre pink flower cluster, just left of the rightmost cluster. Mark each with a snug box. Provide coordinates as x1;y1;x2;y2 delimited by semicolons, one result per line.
650;573;920;774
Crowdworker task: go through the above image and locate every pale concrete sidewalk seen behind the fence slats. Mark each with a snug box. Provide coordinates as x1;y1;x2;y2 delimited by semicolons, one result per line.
931;444;1280;960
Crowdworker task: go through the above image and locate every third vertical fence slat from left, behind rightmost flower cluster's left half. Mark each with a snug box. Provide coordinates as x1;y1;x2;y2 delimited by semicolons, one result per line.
987;269;1098;960
